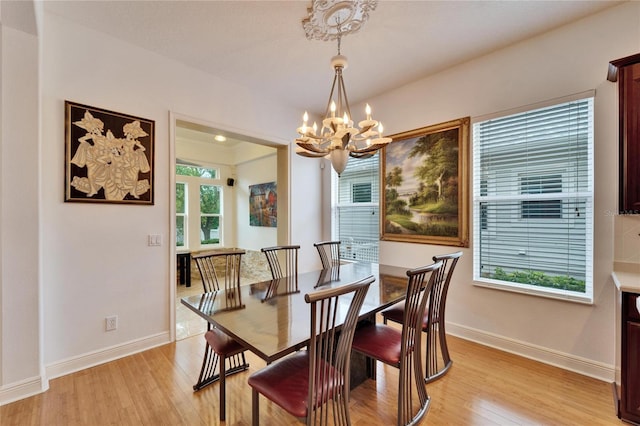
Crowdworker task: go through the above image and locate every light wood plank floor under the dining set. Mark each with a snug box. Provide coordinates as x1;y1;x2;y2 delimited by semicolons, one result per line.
0;335;623;426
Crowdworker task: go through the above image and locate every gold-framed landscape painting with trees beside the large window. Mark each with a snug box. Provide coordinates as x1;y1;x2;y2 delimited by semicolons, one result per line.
380;117;470;247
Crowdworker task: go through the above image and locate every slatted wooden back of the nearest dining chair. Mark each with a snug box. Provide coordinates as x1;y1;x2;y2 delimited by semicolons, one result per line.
305;276;374;425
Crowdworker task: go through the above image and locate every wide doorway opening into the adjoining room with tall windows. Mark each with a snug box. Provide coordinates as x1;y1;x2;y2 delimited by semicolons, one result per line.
169;116;289;340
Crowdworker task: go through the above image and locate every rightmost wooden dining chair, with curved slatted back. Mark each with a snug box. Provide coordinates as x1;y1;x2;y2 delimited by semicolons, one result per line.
381;251;462;383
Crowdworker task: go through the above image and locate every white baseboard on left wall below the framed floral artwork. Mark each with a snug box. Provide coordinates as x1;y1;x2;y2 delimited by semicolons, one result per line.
45;332;171;379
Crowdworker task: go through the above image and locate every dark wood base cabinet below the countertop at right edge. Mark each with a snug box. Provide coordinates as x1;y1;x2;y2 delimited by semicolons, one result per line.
618;292;640;424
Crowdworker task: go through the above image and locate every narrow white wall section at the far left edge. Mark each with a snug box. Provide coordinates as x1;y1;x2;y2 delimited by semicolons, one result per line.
0;15;42;399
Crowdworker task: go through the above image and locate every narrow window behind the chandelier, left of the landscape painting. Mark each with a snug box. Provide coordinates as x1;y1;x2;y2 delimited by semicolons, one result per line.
332;154;380;263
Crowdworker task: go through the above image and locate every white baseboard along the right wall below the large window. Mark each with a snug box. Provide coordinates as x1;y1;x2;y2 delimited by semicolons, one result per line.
446;322;616;383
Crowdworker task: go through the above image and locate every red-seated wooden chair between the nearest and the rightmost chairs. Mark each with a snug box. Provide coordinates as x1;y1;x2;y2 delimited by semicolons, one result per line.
353;262;442;426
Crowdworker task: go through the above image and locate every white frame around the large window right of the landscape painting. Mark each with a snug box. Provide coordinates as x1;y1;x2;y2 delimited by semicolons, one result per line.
470;90;596;305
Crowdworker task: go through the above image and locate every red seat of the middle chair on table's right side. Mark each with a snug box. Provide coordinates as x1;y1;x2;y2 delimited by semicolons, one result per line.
352;324;402;367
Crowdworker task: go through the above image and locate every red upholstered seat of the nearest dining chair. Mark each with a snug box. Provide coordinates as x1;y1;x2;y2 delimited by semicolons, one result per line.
249;350;342;417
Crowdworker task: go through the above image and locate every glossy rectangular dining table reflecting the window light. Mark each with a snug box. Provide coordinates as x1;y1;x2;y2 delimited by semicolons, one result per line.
181;263;409;382
